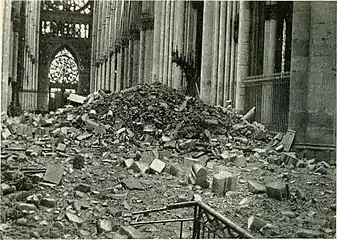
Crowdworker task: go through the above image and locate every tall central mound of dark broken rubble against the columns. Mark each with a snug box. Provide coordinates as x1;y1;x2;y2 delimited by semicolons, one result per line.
48;83;263;143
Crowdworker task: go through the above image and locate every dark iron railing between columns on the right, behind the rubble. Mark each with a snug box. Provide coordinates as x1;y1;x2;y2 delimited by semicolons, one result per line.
244;72;290;132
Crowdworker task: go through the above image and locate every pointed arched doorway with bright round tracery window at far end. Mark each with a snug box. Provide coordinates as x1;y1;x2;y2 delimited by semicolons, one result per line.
48;47;79;110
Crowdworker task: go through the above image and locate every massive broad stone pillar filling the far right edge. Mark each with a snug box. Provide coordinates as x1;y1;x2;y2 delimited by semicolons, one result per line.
306;1;337;149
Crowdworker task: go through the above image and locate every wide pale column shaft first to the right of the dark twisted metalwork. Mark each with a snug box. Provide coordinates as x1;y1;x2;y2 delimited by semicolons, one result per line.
200;1;214;104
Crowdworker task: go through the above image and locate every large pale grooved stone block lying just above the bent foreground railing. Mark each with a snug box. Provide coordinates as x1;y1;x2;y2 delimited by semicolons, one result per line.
212;171;238;195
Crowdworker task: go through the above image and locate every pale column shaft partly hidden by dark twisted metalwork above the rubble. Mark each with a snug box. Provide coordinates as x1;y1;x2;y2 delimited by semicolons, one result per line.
172;1;185;89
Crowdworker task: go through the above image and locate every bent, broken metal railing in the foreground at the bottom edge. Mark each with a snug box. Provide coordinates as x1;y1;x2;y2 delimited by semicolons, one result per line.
130;201;253;239
